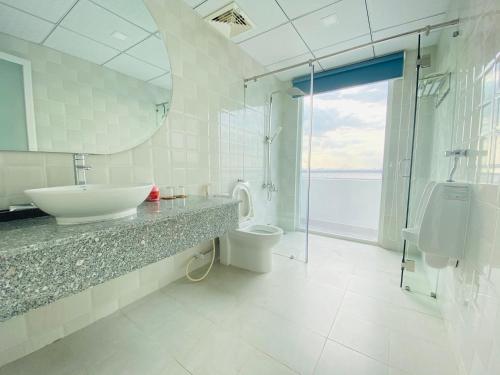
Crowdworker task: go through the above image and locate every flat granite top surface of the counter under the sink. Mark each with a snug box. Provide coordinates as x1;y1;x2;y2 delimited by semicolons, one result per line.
0;196;237;257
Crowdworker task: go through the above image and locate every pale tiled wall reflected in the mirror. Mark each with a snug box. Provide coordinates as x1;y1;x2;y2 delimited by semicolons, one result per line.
0;30;170;158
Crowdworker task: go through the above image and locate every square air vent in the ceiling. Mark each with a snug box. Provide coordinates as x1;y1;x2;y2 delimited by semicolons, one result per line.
205;3;254;39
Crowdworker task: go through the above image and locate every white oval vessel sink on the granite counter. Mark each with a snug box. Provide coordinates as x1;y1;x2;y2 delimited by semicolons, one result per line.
24;184;152;225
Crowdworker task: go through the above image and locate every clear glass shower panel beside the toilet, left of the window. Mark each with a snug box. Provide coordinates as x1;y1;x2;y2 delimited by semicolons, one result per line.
244;64;312;262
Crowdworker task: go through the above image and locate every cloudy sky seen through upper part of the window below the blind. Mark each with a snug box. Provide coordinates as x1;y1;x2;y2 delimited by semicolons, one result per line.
302;81;388;170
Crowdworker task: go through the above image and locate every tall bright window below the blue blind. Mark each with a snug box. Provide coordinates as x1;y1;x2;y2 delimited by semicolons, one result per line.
301;81;388;241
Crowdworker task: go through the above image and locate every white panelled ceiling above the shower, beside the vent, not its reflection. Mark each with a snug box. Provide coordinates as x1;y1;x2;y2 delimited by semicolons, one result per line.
185;0;453;79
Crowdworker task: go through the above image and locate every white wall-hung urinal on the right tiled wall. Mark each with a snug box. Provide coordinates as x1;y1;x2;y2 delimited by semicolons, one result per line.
418;182;471;259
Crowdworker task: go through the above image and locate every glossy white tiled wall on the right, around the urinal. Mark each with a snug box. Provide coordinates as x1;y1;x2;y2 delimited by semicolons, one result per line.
431;0;500;375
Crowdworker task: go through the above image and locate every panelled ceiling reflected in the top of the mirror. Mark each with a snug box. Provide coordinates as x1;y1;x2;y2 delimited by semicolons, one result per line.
0;0;171;89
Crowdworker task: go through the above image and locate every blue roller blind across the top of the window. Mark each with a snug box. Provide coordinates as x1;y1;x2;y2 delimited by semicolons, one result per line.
292;52;404;94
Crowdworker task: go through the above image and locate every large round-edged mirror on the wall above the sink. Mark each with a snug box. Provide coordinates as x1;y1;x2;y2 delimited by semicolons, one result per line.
0;0;172;154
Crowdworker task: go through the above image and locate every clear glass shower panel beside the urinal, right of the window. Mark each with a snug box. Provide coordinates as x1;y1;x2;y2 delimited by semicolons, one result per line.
402;29;458;297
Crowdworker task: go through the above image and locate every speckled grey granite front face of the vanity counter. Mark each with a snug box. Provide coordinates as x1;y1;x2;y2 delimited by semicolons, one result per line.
0;200;238;322
